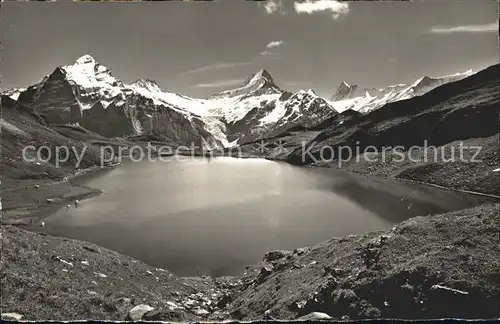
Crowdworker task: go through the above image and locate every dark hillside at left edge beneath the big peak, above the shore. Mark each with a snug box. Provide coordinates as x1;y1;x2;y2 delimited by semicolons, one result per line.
0;96;118;185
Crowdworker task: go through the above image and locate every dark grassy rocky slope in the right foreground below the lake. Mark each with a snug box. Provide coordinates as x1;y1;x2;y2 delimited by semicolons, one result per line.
221;204;500;320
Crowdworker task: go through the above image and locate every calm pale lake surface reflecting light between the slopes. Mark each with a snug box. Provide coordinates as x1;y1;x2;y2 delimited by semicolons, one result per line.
43;157;488;276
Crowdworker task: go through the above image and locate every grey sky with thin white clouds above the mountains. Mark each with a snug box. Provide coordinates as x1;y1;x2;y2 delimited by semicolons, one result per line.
0;0;499;98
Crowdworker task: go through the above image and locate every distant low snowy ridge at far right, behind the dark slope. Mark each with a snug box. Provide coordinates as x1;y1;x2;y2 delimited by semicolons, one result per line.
331;70;474;113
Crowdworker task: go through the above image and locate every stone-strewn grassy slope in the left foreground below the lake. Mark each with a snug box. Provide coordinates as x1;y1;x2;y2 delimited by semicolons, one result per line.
0;226;237;322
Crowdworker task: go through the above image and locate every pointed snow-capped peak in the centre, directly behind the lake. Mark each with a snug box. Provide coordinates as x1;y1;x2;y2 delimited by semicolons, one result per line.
204;70;337;144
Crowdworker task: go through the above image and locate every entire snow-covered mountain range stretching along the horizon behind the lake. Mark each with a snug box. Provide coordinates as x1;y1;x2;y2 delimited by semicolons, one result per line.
2;55;480;149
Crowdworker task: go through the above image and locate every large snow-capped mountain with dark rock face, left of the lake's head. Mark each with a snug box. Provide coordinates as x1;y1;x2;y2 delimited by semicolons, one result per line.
18;55;223;147
